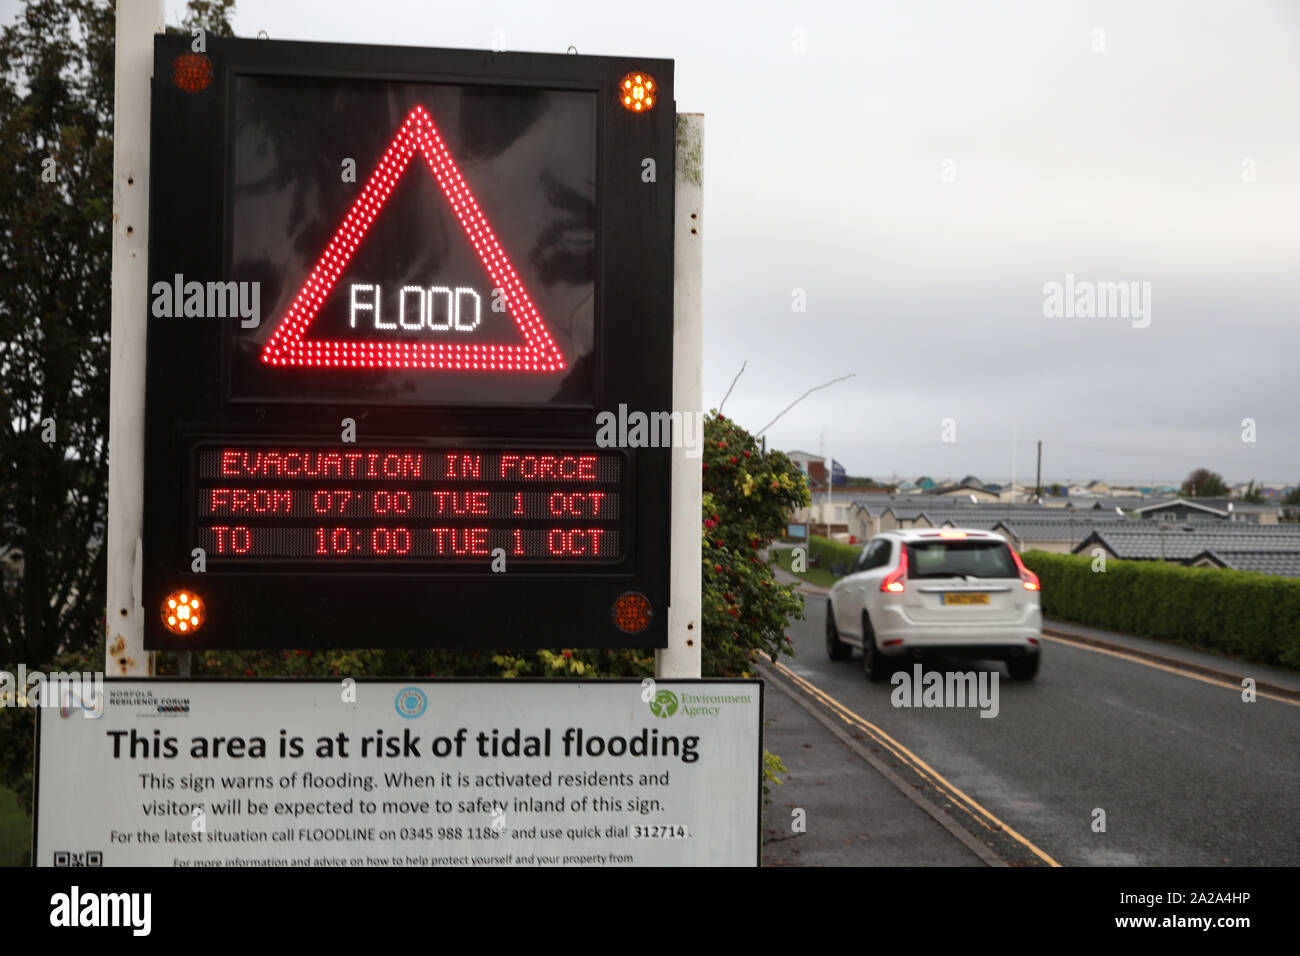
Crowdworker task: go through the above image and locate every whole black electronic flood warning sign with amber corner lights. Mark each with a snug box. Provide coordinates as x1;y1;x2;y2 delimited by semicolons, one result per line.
143;35;675;649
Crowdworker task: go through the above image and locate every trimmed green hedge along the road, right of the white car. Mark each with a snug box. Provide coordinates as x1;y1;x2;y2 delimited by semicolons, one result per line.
1021;551;1300;670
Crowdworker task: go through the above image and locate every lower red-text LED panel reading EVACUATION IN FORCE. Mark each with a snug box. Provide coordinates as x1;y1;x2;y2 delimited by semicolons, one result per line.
192;445;625;566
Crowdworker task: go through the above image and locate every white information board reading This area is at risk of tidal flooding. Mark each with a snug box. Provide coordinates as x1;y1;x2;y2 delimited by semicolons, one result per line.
33;679;762;866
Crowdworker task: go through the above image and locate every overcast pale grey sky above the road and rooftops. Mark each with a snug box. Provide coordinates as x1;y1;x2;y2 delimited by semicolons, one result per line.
15;0;1300;483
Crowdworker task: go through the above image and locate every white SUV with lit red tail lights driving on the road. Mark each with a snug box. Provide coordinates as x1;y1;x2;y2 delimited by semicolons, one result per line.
826;528;1043;680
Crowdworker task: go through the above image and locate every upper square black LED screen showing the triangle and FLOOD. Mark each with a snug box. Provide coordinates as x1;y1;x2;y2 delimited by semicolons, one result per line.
226;75;597;405
